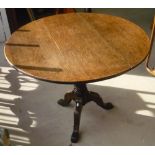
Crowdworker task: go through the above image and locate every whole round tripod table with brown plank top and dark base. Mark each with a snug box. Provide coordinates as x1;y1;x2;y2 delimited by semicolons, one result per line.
4;13;150;142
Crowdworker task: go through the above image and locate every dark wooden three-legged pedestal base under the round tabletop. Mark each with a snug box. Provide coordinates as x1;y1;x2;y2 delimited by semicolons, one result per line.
58;83;113;143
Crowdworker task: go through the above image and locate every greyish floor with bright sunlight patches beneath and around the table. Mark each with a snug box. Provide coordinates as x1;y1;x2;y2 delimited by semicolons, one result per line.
0;9;155;146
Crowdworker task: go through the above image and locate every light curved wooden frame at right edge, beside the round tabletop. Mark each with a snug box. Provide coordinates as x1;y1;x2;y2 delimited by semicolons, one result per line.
146;17;155;76
